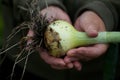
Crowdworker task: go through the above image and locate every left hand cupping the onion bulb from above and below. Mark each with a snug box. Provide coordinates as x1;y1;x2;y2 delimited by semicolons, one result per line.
37;6;73;69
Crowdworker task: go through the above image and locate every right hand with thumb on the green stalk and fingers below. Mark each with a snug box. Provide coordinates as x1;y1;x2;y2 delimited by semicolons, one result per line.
64;11;108;68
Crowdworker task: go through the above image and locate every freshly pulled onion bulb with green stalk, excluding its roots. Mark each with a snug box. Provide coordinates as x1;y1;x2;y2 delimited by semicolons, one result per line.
44;20;120;57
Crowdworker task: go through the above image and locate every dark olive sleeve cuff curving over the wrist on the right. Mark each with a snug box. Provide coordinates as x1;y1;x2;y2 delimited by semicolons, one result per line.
75;1;118;31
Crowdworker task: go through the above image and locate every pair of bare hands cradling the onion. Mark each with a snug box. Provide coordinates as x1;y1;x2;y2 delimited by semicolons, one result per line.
28;6;108;70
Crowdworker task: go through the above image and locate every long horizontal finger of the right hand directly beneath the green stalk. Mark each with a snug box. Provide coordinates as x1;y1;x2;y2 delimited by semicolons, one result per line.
67;44;108;60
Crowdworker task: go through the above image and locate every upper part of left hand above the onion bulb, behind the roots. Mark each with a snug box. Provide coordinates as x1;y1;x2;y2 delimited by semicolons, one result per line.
40;6;71;23
